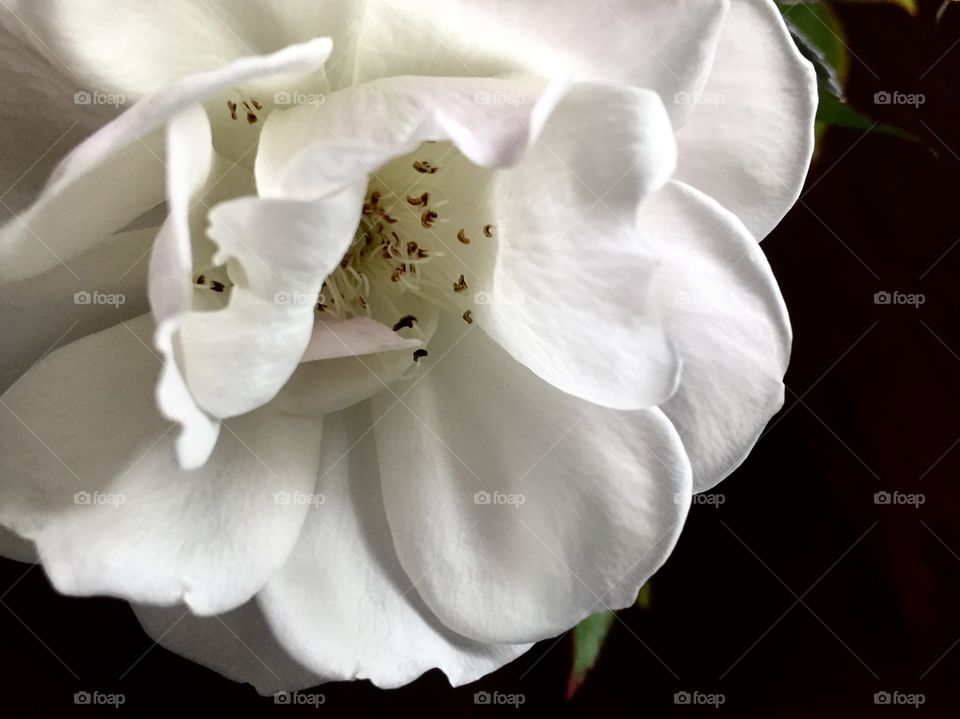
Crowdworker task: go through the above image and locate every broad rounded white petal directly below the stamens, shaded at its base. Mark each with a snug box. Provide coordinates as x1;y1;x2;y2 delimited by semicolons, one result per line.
371;327;691;642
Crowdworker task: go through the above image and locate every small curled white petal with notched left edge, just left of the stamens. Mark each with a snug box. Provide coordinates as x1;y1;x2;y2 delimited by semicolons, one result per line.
174;188;366;417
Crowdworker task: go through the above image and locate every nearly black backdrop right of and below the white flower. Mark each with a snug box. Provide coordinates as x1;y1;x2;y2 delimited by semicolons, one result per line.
0;3;960;717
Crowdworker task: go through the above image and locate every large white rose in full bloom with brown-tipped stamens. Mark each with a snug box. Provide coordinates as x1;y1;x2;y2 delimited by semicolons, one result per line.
0;0;816;693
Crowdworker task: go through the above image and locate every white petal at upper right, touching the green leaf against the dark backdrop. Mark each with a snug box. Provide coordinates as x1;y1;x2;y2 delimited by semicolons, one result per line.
676;0;817;240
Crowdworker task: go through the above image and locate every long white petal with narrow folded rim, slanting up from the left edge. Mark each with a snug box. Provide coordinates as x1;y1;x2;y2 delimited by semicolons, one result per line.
0;38;330;281
